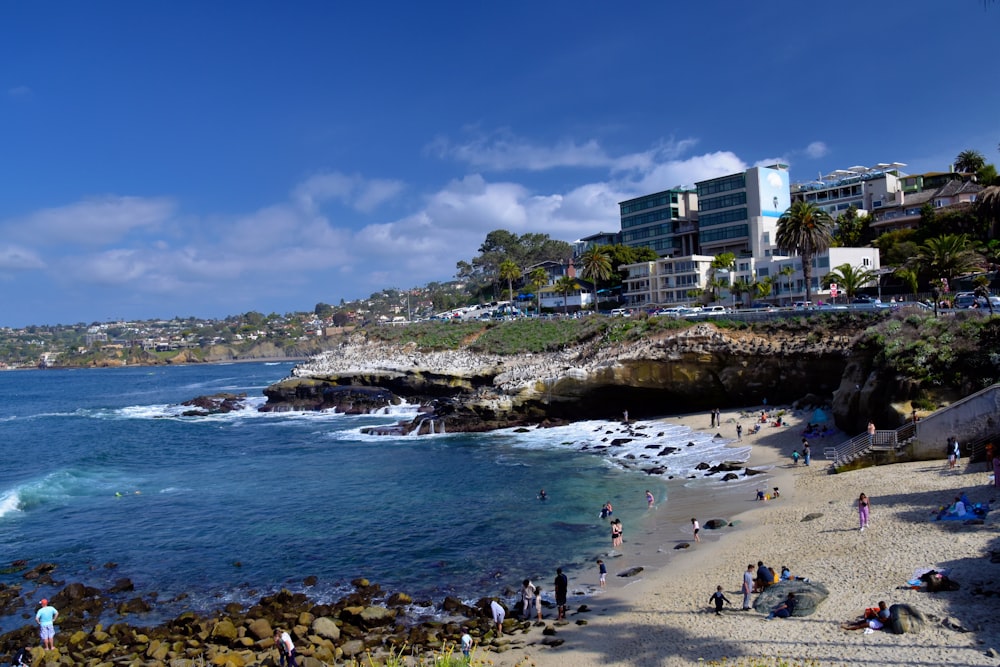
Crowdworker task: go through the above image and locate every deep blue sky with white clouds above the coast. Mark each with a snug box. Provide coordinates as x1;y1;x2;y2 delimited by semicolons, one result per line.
0;0;1000;327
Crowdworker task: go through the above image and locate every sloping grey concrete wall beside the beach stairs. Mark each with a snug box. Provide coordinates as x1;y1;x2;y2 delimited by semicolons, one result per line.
911;384;1000;459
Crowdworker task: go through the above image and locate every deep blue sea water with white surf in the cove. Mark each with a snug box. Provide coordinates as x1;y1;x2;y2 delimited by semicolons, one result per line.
0;364;749;630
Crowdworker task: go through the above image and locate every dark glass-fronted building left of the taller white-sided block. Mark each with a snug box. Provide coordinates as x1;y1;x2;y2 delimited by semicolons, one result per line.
618;188;698;257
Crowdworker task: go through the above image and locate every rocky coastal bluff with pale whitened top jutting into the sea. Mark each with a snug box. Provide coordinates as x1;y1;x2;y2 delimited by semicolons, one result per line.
262;323;889;433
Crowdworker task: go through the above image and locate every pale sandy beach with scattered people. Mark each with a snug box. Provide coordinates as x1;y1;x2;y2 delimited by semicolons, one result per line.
483;411;1000;667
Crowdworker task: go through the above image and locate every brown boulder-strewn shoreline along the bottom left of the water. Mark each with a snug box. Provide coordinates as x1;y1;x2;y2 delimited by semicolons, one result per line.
0;561;572;667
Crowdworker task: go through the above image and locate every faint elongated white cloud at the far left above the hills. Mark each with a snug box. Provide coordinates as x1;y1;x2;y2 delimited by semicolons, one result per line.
3;195;175;245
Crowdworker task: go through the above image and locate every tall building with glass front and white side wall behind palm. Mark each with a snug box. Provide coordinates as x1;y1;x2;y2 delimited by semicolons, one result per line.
695;164;791;258
